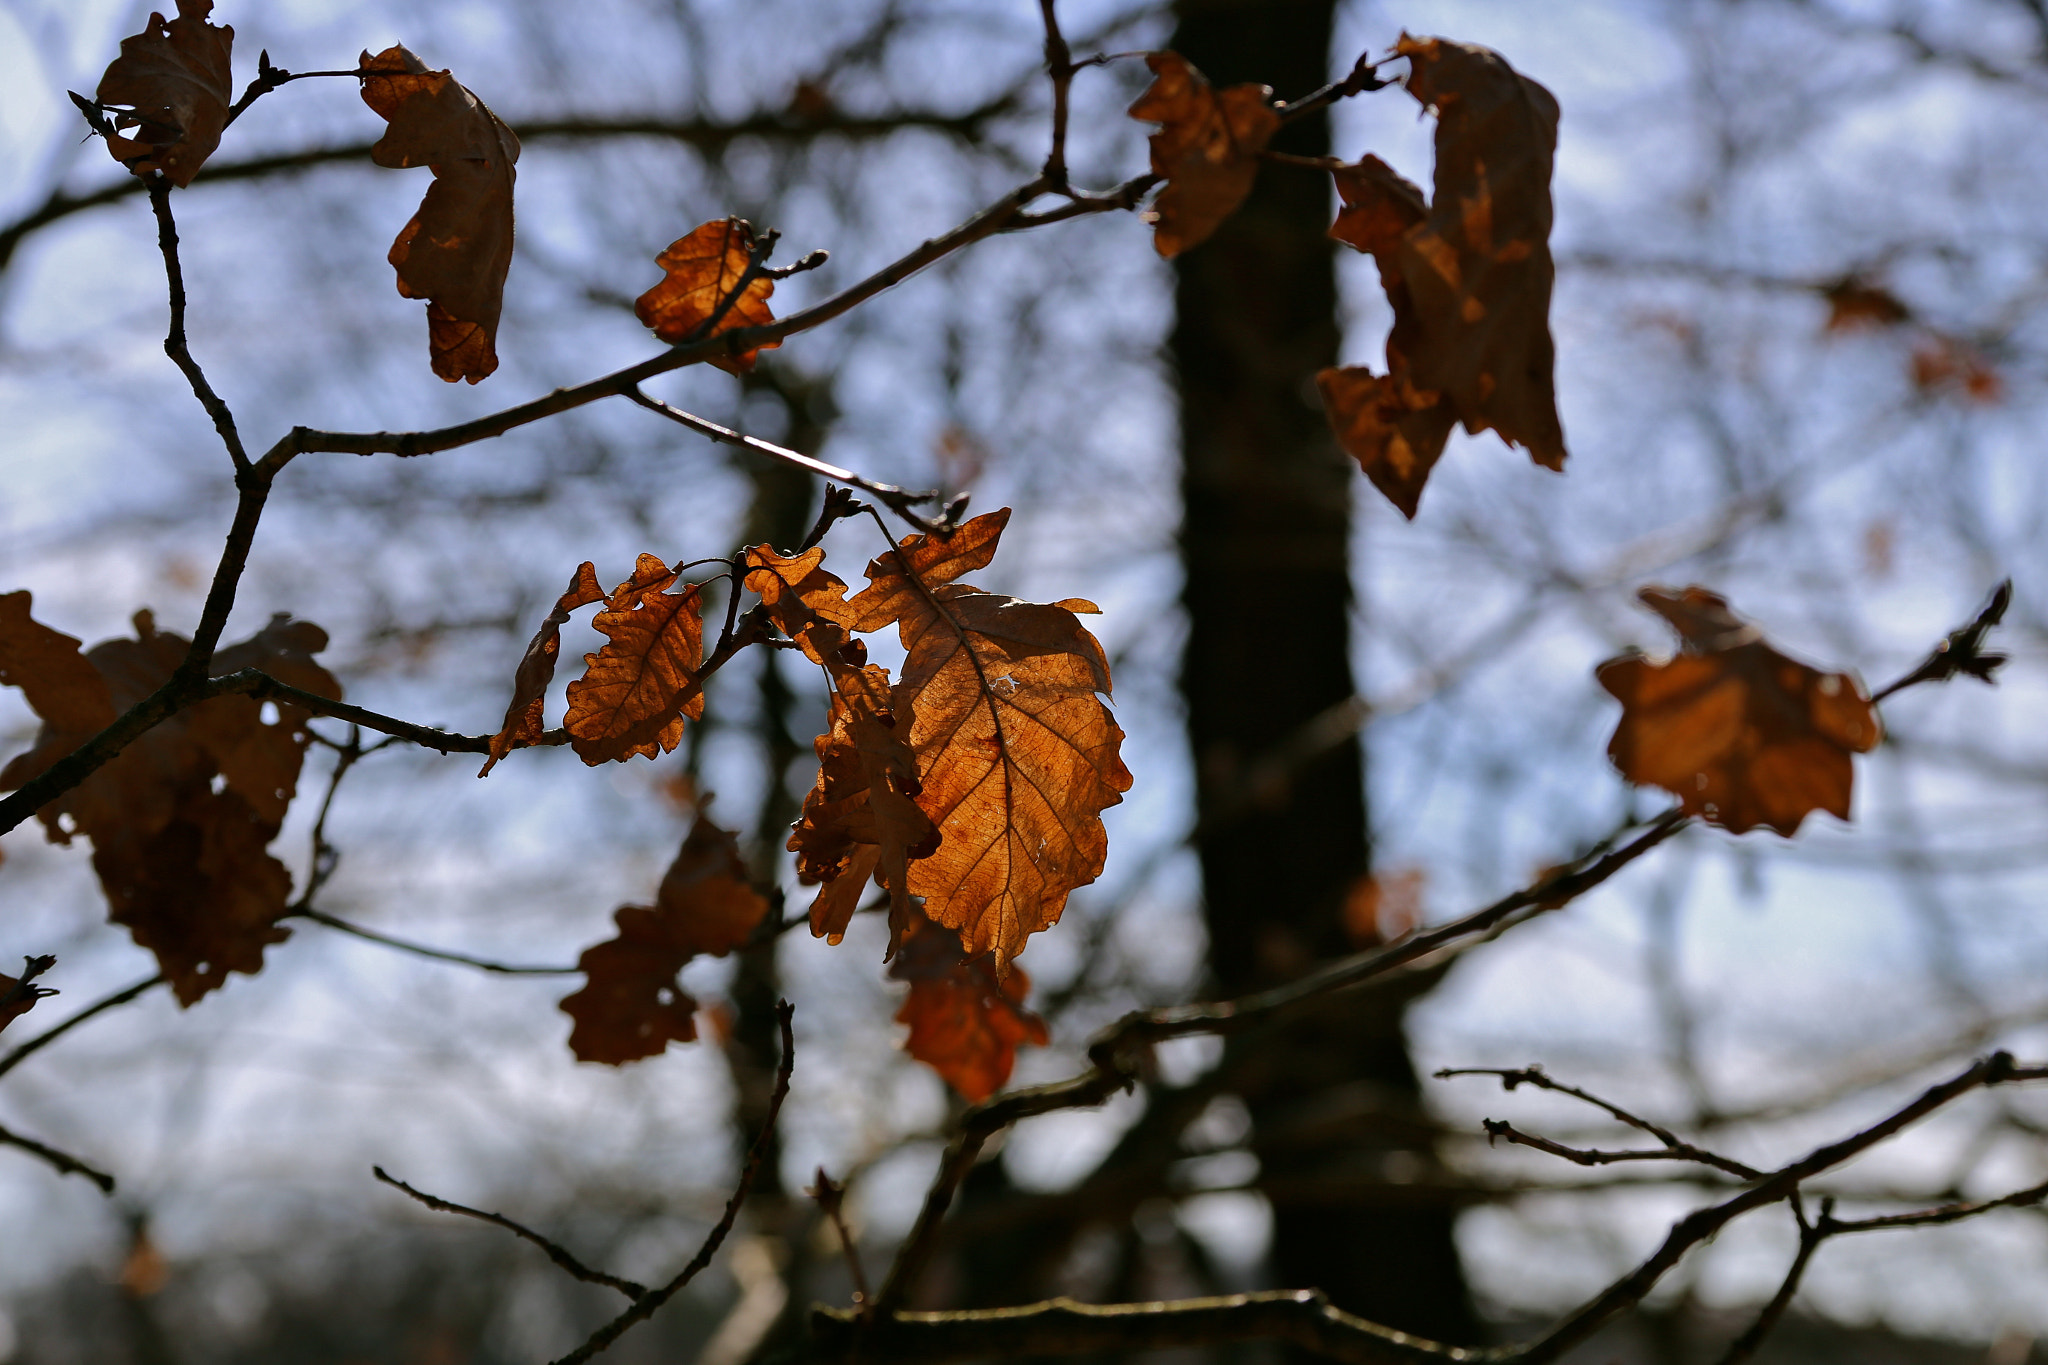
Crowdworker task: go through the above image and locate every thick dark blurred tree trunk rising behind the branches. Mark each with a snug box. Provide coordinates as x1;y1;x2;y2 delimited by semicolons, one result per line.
1171;0;1477;1340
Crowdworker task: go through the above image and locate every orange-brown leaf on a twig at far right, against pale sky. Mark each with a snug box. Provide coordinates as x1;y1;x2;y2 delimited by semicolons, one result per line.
1595;587;1884;837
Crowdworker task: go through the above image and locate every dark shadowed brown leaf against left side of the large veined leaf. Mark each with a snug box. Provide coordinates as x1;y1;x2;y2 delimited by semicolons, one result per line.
788;665;940;956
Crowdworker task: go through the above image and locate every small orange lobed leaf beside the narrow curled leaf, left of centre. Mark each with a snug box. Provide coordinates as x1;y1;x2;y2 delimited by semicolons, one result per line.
563;555;705;767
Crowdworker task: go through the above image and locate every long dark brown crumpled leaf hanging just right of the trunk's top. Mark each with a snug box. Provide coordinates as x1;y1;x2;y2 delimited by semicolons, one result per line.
1319;35;1565;518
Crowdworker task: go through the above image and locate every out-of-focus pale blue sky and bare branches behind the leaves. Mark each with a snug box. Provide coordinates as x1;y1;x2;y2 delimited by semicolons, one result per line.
0;0;2048;1365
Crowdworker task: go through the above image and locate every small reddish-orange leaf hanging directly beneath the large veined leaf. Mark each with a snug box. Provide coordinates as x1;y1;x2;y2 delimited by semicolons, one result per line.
889;917;1047;1103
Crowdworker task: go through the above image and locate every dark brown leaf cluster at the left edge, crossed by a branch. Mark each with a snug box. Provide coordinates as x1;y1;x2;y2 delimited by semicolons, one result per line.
0;591;342;1005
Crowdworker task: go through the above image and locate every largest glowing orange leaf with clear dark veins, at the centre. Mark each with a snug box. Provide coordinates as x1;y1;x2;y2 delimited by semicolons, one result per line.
852;508;1130;970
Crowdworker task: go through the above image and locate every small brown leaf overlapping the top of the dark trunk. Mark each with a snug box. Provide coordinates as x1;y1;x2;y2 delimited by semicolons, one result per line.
1130;51;1280;258
